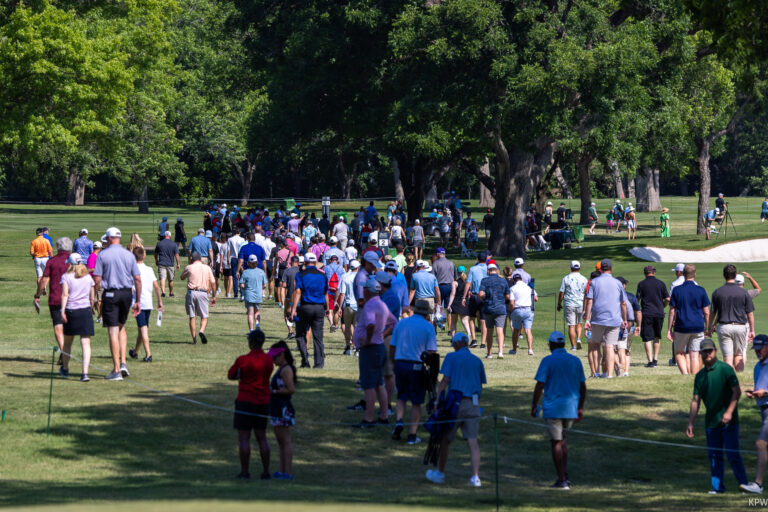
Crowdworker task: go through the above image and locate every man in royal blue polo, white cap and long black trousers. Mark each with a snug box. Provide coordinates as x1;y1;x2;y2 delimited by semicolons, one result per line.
291;252;329;368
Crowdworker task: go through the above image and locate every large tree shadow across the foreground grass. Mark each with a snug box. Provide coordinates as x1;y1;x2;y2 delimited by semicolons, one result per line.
0;372;744;510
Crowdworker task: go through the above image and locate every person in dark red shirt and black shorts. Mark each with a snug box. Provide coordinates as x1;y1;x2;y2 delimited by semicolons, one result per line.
227;329;274;480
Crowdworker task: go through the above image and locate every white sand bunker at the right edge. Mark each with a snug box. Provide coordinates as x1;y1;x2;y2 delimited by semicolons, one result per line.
629;238;768;263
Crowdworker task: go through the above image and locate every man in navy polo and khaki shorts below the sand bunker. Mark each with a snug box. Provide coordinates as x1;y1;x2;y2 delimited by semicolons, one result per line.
667;264;710;375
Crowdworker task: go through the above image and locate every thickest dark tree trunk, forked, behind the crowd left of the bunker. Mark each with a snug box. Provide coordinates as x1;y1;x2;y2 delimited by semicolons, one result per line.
491;132;557;257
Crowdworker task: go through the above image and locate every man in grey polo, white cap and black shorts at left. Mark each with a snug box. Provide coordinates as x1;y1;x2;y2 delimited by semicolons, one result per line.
93;228;141;380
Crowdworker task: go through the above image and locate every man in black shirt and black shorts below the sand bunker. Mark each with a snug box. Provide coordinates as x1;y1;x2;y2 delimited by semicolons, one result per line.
635;265;669;368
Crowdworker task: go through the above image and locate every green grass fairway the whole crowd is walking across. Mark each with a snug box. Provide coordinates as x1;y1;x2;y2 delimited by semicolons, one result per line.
0;198;768;511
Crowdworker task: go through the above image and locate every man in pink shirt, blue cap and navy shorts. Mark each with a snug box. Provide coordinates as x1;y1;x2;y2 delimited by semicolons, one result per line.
352;278;397;428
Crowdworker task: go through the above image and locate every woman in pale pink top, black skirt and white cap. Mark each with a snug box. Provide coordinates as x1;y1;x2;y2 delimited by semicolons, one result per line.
59;252;96;382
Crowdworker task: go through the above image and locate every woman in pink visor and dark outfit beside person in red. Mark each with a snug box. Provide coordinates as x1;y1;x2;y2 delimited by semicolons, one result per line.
267;341;297;480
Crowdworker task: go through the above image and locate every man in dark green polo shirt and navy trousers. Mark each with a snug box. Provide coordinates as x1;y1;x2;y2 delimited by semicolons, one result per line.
685;338;747;494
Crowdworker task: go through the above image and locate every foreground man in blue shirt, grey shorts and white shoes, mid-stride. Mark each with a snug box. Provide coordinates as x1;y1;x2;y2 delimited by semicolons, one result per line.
426;332;486;487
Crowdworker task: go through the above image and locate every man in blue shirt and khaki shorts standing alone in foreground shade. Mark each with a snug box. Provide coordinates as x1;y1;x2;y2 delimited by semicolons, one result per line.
531;331;587;489
